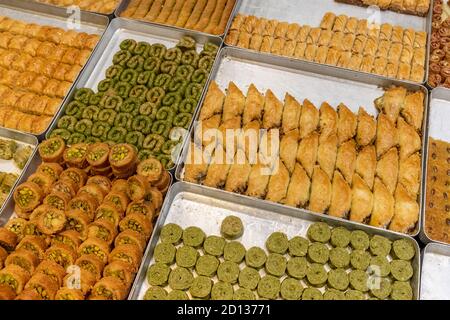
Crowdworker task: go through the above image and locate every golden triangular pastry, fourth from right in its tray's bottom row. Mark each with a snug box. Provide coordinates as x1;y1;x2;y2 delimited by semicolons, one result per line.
328;171;352;218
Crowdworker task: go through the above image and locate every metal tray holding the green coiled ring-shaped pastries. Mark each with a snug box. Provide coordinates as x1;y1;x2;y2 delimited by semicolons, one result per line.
47;18;222;169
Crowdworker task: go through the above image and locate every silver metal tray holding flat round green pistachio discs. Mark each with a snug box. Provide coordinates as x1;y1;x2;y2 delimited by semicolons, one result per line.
129;182;420;300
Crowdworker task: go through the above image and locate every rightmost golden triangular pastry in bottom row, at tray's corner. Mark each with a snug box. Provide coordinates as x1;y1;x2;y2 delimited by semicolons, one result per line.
389;184;419;233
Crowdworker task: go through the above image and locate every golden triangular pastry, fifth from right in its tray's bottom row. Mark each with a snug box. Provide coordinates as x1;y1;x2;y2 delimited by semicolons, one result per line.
308;166;332;213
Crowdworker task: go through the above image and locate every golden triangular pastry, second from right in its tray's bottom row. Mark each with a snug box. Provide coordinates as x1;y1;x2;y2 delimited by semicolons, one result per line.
370;178;395;228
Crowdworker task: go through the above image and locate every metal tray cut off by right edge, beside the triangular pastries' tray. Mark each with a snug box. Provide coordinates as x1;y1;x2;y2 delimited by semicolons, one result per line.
420;87;450;245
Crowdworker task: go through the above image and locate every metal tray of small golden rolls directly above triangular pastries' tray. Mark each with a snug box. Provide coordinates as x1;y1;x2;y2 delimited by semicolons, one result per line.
225;0;433;84
